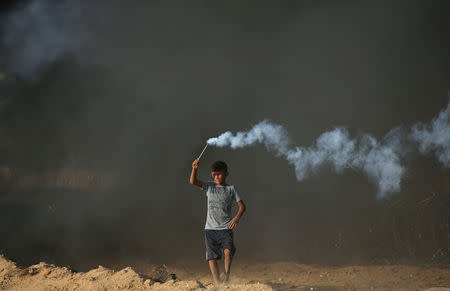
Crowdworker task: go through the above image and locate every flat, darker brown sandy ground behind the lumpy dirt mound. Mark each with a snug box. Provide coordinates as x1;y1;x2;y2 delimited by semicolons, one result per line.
165;262;450;291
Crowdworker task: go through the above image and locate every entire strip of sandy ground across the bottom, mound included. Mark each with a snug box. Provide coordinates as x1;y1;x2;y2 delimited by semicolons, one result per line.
0;256;450;291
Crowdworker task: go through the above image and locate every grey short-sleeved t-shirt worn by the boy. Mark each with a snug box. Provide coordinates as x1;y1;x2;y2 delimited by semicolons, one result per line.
202;182;241;229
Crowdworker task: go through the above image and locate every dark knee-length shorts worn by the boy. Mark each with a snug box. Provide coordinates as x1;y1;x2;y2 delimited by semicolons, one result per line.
205;229;236;261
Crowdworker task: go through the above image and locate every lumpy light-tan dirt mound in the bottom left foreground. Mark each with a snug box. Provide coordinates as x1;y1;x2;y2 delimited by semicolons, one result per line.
0;255;273;290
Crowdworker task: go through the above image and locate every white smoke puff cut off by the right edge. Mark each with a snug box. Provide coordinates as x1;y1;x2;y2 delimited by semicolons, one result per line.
411;103;450;167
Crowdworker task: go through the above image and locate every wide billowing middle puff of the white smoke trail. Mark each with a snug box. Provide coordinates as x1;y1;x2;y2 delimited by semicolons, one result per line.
286;128;405;197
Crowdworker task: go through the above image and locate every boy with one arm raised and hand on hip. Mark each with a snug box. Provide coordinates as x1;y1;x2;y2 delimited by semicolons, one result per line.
190;159;245;285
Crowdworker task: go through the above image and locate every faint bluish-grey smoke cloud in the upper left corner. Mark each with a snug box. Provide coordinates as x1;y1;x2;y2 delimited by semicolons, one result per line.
0;0;92;79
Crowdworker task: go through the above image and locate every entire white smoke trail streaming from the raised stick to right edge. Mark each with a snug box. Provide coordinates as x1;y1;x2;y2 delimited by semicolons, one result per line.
207;101;450;197
